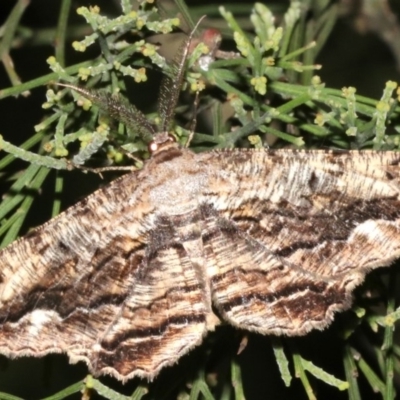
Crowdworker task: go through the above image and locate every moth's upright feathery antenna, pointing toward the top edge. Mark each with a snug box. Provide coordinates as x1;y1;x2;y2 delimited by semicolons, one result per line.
158;16;205;132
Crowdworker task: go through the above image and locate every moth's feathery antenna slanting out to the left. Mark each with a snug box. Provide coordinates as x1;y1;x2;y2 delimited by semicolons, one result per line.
56;82;157;140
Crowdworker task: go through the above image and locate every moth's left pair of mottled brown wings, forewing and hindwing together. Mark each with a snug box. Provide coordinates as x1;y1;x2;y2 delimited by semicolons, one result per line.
0;148;215;381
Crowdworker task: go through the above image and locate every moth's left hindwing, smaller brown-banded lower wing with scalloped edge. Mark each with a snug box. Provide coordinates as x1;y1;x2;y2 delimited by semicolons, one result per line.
89;219;213;380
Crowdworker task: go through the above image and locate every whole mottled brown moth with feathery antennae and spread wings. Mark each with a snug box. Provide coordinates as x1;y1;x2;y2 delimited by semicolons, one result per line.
0;17;400;382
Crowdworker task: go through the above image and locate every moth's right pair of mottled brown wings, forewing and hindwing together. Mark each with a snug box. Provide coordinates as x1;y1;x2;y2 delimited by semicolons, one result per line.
200;150;400;335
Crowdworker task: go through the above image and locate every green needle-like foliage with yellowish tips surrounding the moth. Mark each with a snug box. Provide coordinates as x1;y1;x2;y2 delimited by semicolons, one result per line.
0;0;400;400
